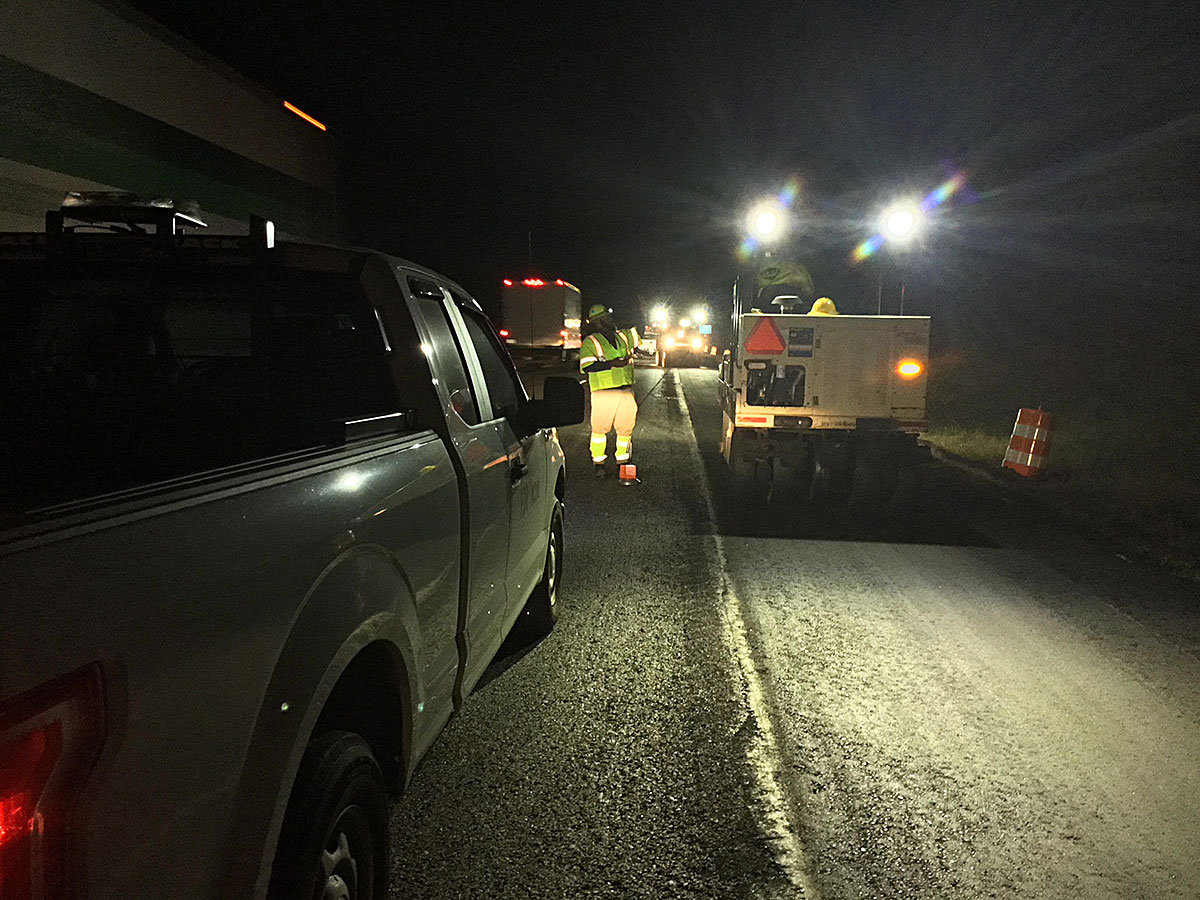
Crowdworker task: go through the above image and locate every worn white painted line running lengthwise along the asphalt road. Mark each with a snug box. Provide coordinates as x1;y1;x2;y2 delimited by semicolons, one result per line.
674;376;821;900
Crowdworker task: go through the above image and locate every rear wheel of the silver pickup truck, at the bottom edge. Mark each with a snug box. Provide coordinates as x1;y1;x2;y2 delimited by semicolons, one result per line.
266;731;389;900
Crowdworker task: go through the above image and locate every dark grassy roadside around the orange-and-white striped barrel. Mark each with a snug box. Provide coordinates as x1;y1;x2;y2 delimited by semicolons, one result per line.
925;340;1200;580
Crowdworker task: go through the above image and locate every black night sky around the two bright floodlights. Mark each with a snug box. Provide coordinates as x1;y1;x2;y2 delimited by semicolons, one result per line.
124;0;1200;341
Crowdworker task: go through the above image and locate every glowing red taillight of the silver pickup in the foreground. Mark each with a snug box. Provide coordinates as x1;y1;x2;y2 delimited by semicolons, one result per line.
0;665;104;900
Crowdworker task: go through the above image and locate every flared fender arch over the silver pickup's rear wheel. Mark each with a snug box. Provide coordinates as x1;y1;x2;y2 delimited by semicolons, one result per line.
214;545;421;898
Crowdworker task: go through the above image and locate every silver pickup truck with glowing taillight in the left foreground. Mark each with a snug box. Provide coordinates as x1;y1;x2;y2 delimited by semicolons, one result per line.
0;197;583;900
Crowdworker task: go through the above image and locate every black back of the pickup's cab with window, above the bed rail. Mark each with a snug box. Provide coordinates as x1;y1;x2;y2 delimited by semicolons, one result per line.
0;264;412;518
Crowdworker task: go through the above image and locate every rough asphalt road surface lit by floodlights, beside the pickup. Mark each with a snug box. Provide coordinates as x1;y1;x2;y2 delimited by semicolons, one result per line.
392;368;1200;900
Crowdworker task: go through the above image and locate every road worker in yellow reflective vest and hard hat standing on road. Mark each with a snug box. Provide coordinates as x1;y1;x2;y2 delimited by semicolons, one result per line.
580;304;640;478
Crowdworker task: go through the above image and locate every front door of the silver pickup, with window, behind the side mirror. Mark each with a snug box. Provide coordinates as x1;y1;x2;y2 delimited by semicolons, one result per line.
456;305;551;618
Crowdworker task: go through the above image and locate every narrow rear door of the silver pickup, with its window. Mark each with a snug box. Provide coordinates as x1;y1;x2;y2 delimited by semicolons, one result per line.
408;282;511;694
